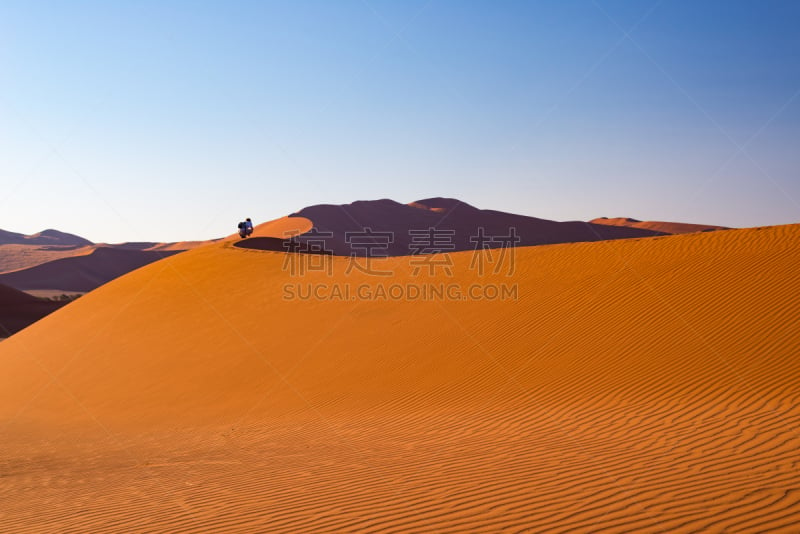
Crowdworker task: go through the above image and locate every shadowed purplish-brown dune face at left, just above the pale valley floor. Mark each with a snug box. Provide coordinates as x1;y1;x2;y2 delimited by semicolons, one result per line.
0;247;178;292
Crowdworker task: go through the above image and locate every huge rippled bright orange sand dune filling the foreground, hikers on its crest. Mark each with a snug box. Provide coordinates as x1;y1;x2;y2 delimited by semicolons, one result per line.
0;225;800;532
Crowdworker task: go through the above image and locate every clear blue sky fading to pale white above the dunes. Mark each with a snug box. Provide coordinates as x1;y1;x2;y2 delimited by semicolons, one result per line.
0;0;800;242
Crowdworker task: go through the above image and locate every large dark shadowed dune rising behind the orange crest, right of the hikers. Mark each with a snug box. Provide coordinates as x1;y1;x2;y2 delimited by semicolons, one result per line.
272;198;663;256
